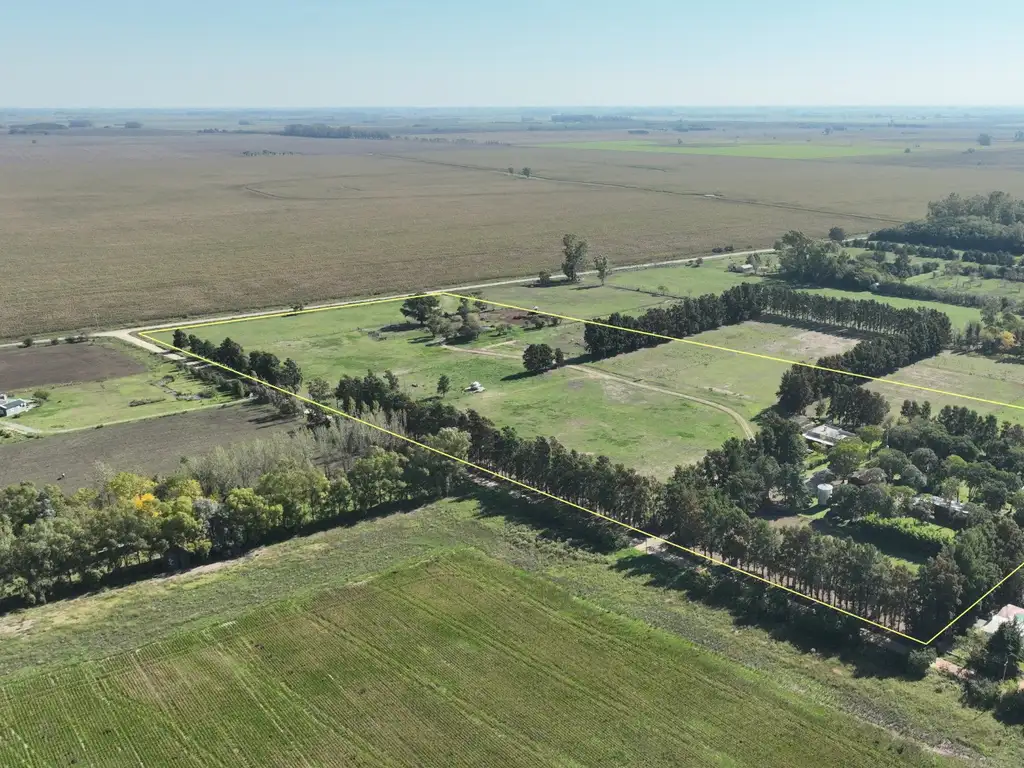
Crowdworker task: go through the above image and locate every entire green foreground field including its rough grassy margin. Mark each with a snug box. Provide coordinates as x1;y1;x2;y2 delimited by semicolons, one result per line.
0;494;1007;766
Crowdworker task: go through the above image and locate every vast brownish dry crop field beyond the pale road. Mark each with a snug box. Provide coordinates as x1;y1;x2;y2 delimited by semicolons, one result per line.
6;132;1024;338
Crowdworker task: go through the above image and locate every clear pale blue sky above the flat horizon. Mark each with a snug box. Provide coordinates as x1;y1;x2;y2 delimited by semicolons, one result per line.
0;0;1024;106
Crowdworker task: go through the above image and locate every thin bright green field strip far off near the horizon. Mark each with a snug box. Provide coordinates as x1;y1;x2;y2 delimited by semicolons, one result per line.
538;139;905;160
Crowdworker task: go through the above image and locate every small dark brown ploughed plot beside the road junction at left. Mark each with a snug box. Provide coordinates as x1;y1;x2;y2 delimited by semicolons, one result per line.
0;343;146;392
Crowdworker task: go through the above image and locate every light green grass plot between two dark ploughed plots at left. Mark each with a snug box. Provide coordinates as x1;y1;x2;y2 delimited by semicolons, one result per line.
17;350;229;430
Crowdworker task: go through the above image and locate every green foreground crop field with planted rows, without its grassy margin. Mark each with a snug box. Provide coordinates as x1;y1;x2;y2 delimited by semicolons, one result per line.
0;552;935;768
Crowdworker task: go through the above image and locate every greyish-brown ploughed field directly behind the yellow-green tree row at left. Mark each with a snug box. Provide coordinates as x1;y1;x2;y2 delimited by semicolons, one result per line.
0;404;298;490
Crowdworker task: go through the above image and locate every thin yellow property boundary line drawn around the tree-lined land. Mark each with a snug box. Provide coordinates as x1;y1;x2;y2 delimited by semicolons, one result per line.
138;291;1024;645
